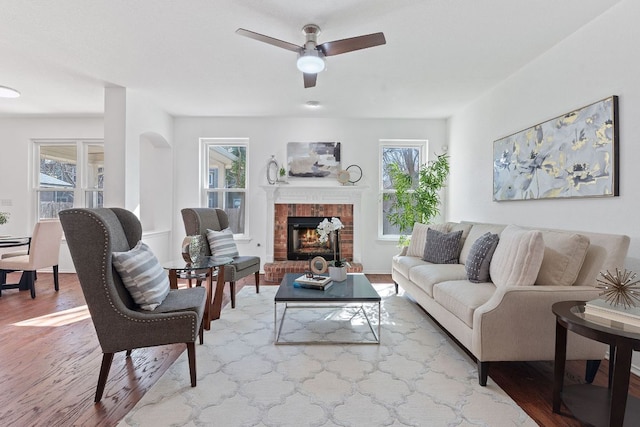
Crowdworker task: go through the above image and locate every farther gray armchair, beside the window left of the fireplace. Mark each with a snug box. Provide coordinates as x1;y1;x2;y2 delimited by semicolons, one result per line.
181;208;260;308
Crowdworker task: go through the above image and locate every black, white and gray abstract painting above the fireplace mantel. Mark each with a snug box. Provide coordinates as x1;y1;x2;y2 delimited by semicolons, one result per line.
287;142;340;179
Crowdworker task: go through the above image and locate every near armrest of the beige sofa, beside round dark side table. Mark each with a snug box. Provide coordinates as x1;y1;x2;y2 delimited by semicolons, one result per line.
472;286;606;361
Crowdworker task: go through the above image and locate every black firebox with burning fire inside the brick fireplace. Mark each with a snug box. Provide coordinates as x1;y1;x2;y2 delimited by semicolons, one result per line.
287;216;340;261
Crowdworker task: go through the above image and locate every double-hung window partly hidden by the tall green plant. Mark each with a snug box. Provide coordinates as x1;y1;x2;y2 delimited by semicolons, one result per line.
378;140;427;240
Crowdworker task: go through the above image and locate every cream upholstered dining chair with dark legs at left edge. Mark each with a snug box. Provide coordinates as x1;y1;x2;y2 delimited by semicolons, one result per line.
0;220;62;298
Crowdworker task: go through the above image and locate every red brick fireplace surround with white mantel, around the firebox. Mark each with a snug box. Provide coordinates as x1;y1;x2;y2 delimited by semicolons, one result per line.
263;184;367;282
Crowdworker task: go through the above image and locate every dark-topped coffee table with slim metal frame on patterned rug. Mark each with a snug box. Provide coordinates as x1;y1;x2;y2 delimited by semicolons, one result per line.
273;273;382;344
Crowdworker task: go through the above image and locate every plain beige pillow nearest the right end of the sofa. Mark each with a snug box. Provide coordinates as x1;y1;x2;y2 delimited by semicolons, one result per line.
536;230;589;286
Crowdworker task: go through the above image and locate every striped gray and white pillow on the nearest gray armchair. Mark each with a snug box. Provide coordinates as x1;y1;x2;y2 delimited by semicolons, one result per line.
113;241;169;311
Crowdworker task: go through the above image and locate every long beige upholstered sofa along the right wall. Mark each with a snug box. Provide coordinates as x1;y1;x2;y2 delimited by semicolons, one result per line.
392;222;629;386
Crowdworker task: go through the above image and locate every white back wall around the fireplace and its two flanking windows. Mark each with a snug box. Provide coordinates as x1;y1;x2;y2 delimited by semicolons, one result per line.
172;118;446;273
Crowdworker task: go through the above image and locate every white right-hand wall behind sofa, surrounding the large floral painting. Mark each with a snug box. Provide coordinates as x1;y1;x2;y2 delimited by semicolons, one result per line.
448;0;640;272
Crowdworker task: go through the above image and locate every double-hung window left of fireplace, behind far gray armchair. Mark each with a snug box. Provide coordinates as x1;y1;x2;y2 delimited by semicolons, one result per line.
200;138;248;235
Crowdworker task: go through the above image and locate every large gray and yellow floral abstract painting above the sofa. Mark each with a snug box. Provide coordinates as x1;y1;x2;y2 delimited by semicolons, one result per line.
493;96;619;201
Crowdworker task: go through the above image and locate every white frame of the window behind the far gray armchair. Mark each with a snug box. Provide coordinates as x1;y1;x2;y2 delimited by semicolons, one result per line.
200;137;251;240
